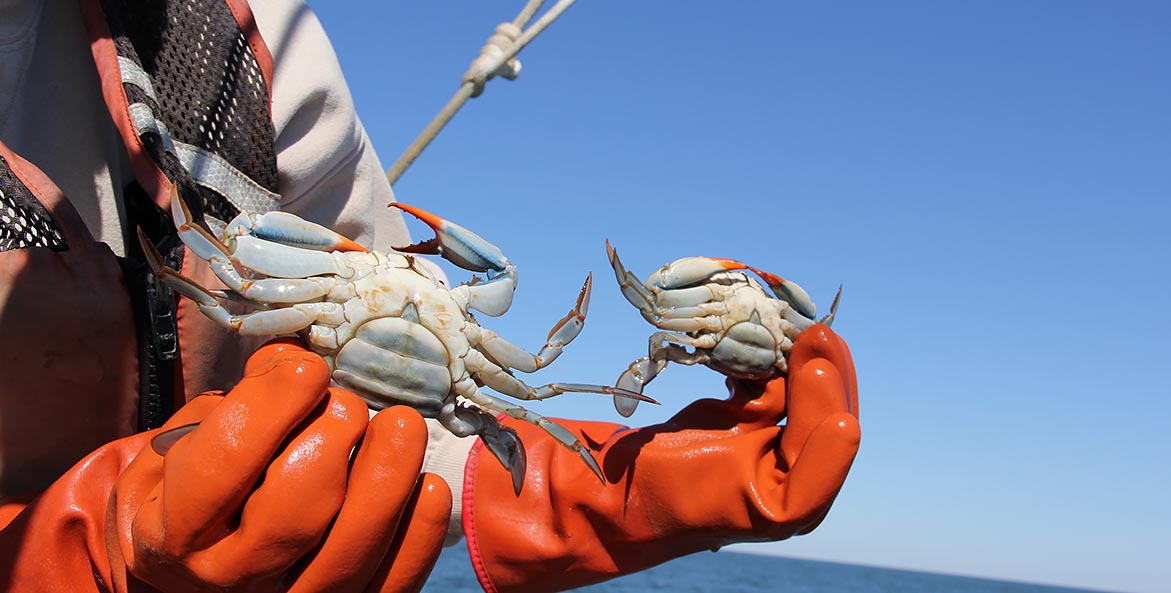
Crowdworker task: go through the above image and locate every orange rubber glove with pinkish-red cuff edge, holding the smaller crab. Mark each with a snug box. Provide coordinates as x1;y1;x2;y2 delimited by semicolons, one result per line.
463;325;861;593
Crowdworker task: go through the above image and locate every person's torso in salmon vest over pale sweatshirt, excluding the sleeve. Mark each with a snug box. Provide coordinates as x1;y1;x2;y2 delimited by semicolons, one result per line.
0;0;278;495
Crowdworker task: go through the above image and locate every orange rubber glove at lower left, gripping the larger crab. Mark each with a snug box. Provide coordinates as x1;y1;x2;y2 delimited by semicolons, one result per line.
0;341;451;592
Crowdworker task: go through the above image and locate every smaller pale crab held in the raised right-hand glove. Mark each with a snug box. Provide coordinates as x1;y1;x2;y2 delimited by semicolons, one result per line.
605;240;842;416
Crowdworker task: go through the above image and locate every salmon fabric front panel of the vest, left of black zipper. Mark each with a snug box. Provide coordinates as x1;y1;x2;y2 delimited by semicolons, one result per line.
0;143;138;496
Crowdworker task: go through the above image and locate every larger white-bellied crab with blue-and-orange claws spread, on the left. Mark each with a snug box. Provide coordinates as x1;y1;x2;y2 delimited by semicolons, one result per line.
139;190;653;496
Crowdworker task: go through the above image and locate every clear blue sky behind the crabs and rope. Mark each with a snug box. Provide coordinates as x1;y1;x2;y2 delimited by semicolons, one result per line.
311;0;1171;593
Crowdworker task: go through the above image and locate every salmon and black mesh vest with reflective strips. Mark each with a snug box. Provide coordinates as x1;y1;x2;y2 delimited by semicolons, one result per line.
0;0;279;496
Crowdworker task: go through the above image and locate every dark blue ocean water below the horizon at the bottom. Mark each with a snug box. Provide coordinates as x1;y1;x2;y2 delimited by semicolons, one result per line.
423;544;1114;593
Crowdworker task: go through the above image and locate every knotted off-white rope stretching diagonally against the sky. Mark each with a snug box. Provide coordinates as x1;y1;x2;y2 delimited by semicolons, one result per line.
386;0;576;185
